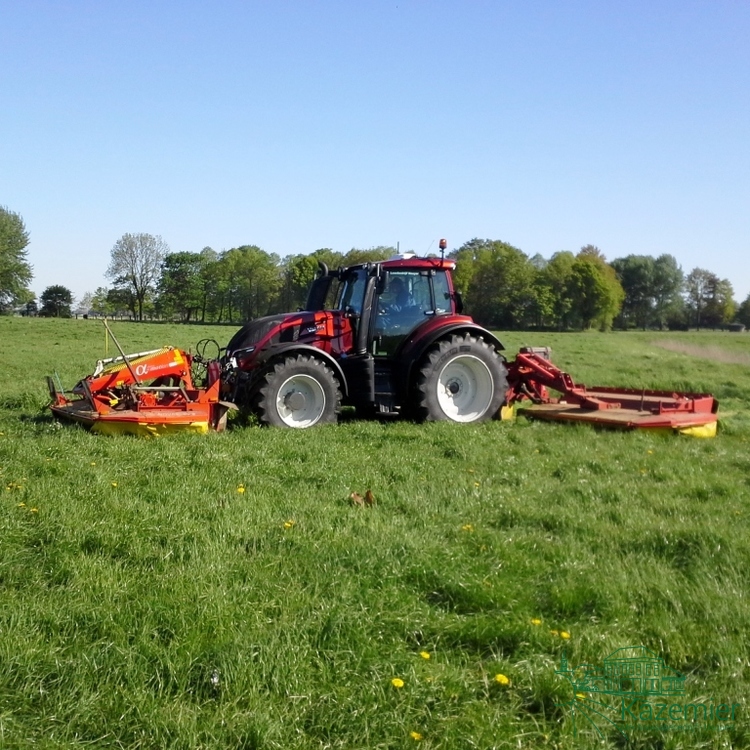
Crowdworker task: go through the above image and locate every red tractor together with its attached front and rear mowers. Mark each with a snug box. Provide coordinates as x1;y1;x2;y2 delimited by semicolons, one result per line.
48;256;718;437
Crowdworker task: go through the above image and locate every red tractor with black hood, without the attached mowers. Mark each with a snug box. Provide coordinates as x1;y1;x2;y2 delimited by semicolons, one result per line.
223;255;507;427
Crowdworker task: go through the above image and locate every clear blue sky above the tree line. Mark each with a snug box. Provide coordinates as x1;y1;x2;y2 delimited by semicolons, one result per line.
0;0;750;300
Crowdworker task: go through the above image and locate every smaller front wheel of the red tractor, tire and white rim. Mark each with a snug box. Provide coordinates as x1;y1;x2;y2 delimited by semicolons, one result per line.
250;354;341;427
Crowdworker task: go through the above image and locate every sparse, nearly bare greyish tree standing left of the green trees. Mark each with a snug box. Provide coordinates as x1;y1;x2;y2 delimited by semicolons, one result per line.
107;234;169;320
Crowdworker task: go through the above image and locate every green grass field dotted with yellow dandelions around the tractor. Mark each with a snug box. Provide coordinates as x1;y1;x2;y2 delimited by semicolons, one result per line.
0;317;750;750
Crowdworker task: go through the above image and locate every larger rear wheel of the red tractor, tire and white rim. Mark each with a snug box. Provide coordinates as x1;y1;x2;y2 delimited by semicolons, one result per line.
416;334;508;422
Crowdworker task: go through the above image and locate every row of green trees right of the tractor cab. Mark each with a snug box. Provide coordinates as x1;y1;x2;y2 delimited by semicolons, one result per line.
453;239;750;330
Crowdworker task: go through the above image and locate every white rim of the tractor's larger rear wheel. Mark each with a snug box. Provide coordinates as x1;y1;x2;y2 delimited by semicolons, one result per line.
437;354;495;422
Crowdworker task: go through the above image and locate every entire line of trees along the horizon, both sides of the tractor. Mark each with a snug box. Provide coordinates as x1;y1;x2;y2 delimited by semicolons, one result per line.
0;207;750;330
